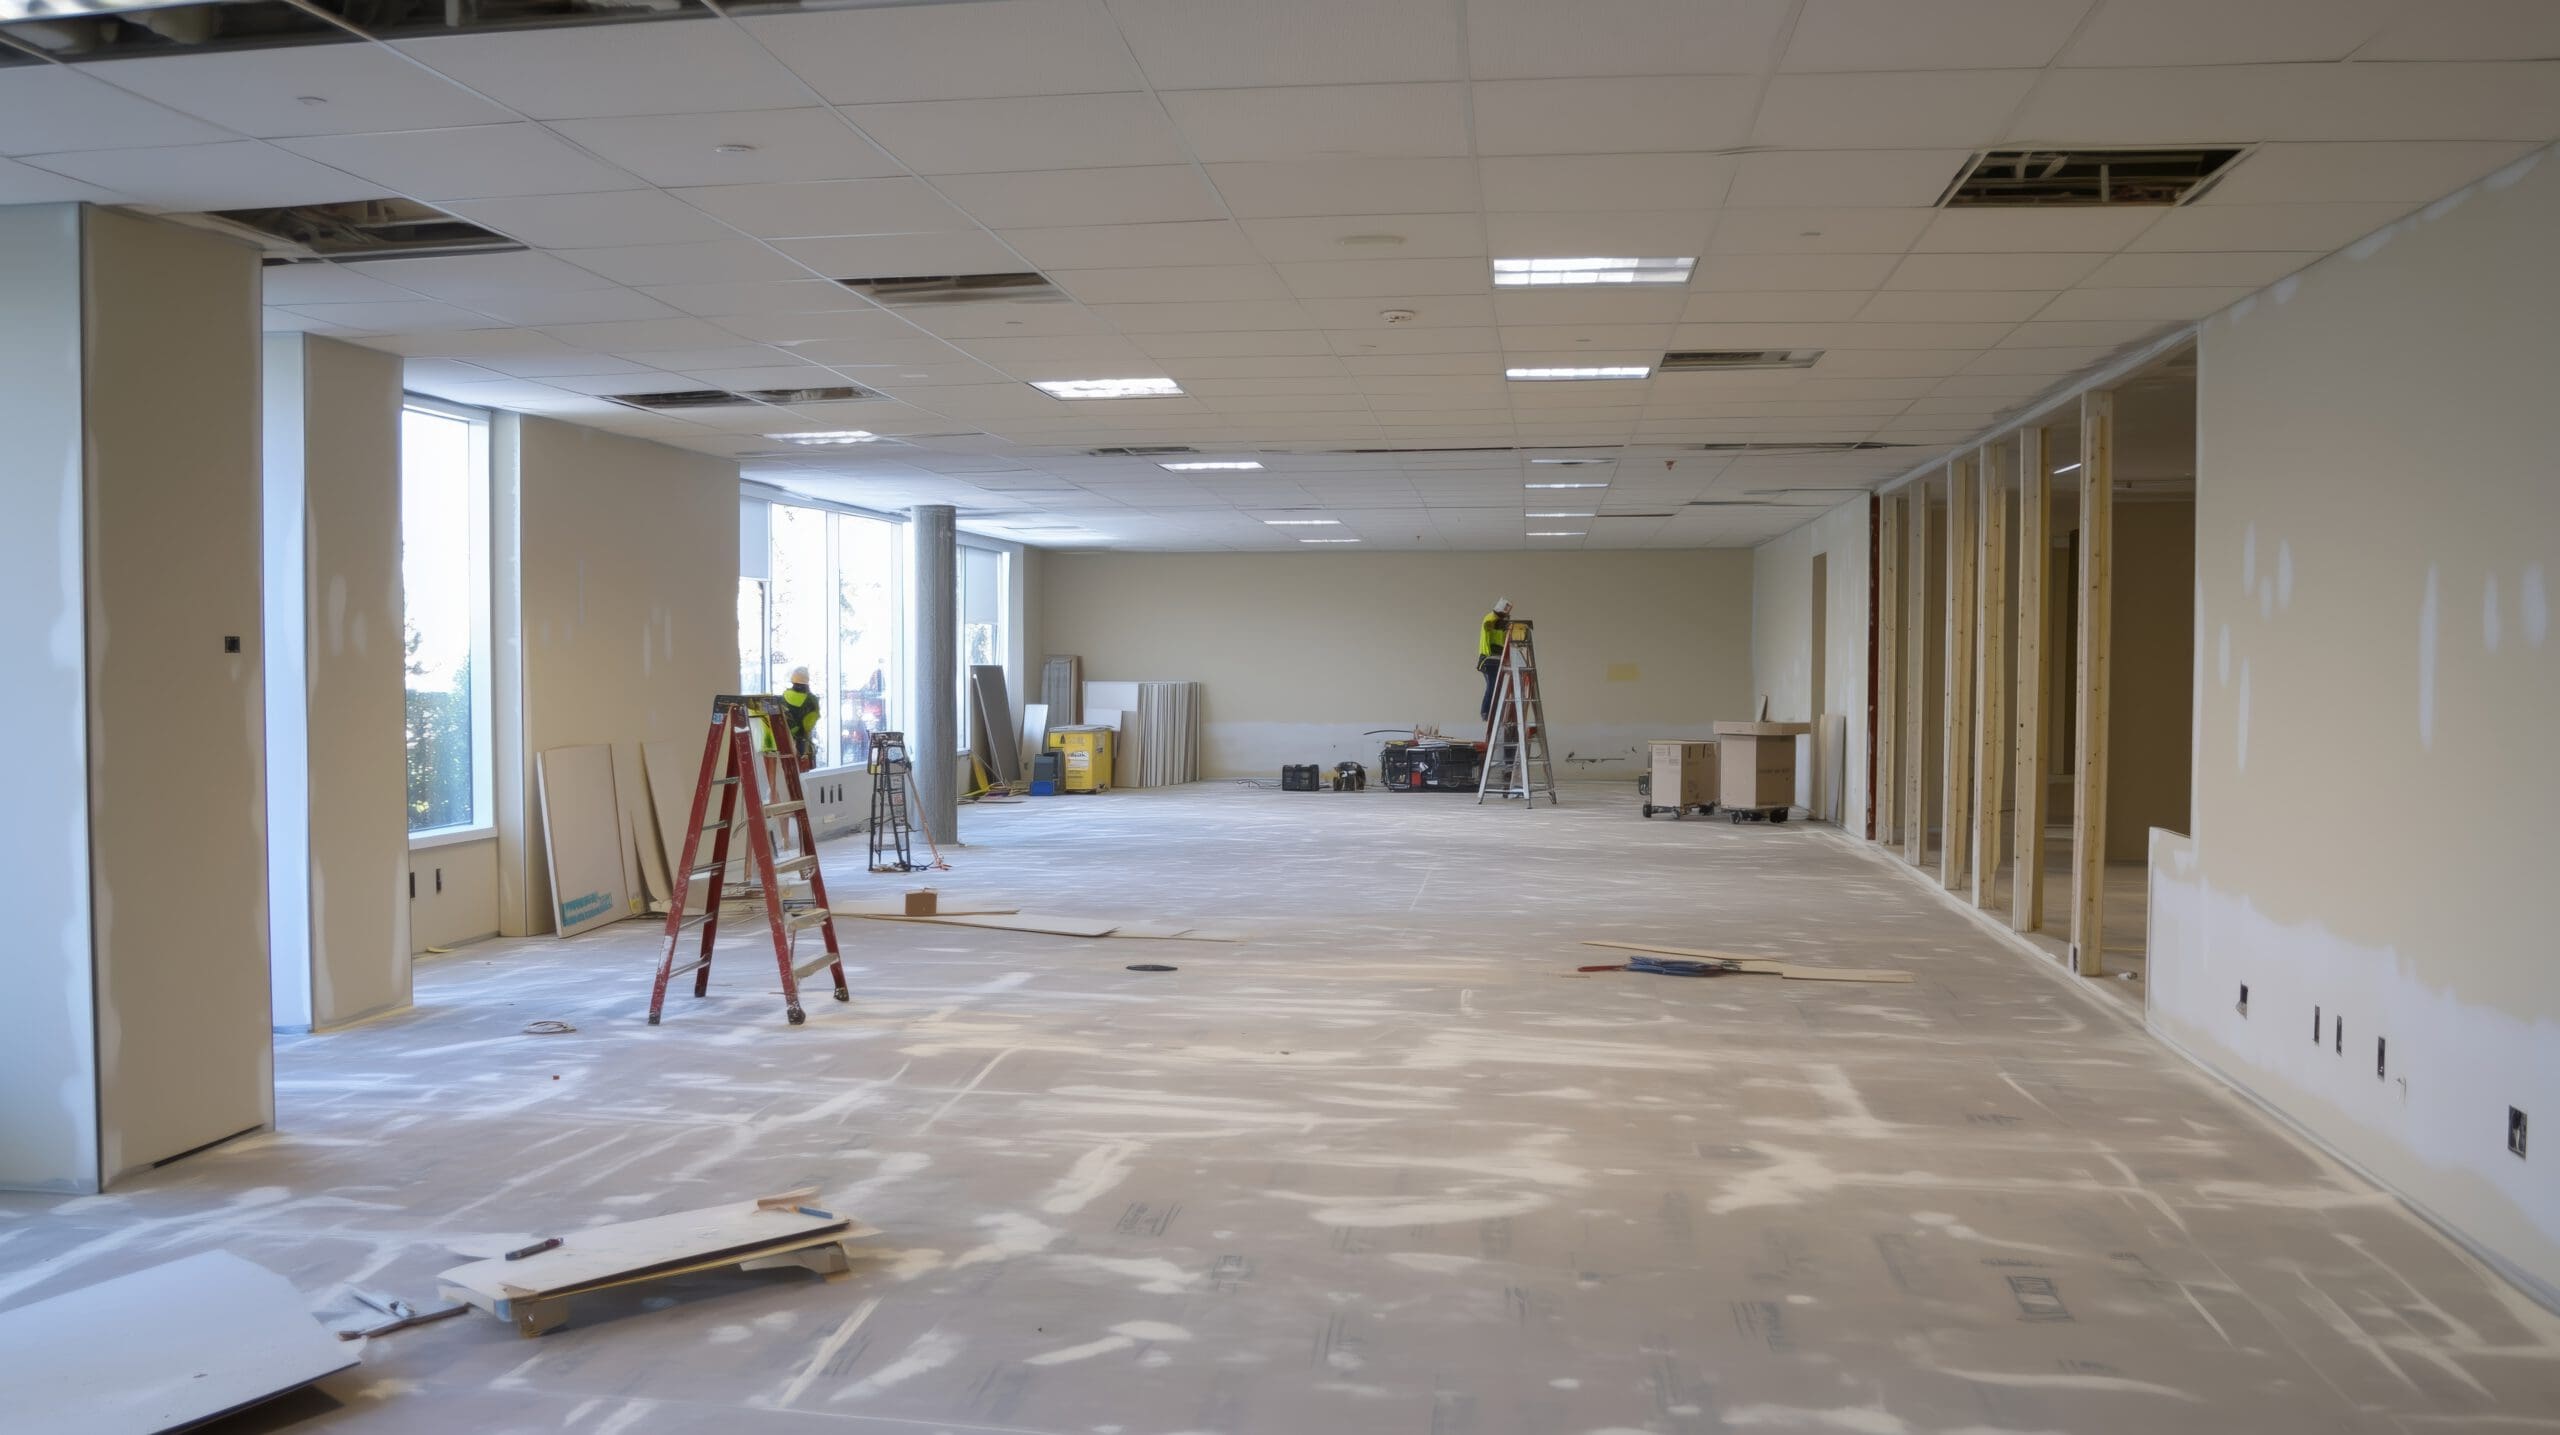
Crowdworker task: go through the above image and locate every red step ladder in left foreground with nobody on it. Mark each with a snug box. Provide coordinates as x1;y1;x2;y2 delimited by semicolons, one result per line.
648;693;852;1026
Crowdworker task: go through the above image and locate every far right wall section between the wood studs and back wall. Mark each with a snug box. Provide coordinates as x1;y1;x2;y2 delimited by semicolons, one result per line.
1751;496;1869;834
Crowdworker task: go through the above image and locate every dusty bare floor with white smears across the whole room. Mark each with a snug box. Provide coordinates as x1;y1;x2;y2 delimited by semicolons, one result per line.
0;785;2560;1435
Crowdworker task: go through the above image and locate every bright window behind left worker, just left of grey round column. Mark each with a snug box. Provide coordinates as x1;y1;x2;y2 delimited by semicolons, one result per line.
737;504;904;767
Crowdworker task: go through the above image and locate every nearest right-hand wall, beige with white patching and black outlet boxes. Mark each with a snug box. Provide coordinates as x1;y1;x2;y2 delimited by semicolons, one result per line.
2150;151;2560;1297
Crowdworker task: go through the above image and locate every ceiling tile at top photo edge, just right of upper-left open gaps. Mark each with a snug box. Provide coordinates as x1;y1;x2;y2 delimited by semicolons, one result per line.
742;0;1144;105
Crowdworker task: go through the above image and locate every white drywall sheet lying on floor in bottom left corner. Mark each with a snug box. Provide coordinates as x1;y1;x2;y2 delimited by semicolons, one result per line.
0;1251;358;1435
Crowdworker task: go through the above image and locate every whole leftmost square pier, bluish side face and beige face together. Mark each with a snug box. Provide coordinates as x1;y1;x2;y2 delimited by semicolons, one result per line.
0;205;274;1192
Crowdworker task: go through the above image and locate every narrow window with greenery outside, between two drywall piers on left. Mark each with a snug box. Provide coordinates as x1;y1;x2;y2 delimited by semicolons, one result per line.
399;399;492;836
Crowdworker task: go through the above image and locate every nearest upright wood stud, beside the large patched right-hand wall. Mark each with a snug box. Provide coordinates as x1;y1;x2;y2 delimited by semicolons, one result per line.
2071;389;2115;977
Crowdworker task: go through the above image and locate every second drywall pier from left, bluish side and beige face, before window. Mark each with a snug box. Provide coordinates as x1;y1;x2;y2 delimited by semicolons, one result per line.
264;335;410;1031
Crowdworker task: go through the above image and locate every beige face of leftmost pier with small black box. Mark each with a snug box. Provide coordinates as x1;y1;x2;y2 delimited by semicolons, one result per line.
82;210;274;1182
